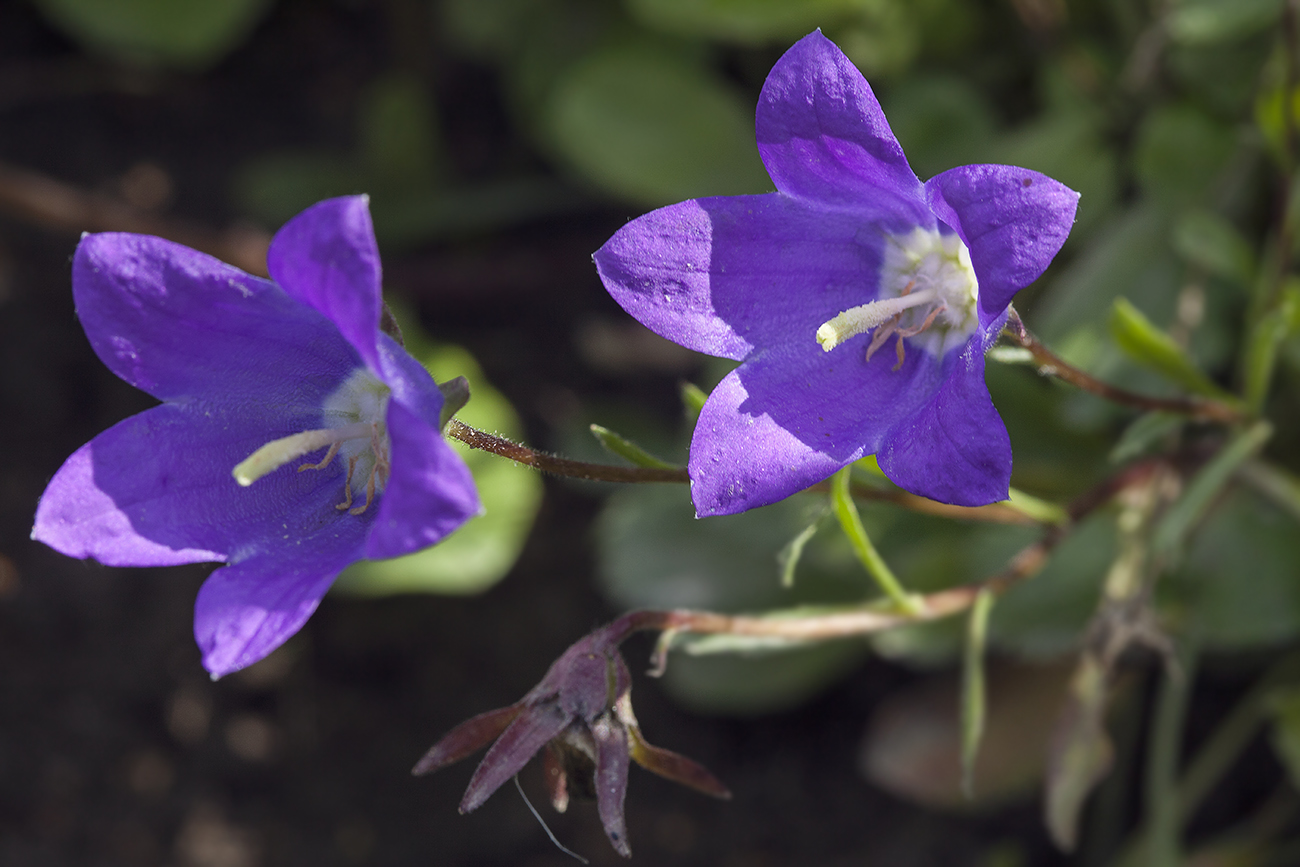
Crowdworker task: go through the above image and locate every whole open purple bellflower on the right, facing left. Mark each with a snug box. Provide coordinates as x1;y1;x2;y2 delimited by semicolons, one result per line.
594;31;1079;516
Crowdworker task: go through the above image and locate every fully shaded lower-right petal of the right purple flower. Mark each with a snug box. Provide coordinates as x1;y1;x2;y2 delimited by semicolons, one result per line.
876;335;1011;506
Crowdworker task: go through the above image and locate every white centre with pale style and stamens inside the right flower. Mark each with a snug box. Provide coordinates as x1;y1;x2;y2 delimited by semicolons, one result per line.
816;226;979;369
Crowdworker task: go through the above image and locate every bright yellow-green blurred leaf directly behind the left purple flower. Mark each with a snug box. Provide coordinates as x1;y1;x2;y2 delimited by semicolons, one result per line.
334;332;542;597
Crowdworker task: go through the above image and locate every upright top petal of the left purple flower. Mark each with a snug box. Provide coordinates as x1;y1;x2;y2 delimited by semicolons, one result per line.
267;196;382;370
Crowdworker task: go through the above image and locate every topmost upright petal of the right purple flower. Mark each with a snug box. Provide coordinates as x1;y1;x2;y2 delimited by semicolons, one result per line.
757;30;933;220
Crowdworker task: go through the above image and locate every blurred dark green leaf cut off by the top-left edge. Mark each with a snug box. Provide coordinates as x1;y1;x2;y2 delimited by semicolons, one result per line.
33;0;270;70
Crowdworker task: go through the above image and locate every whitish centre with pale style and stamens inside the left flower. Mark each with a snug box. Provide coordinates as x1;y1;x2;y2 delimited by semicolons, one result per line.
234;368;391;515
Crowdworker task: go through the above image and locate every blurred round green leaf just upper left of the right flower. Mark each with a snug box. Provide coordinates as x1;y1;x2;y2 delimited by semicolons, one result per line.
546;44;772;205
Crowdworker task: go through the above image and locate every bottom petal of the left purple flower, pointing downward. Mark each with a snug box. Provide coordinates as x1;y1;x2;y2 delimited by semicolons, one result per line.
194;520;365;677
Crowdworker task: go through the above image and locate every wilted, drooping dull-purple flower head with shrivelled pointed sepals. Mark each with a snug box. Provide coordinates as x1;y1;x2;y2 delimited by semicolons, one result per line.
411;617;731;858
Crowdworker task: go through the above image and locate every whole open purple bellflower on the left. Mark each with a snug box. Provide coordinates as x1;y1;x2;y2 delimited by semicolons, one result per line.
31;196;480;676
